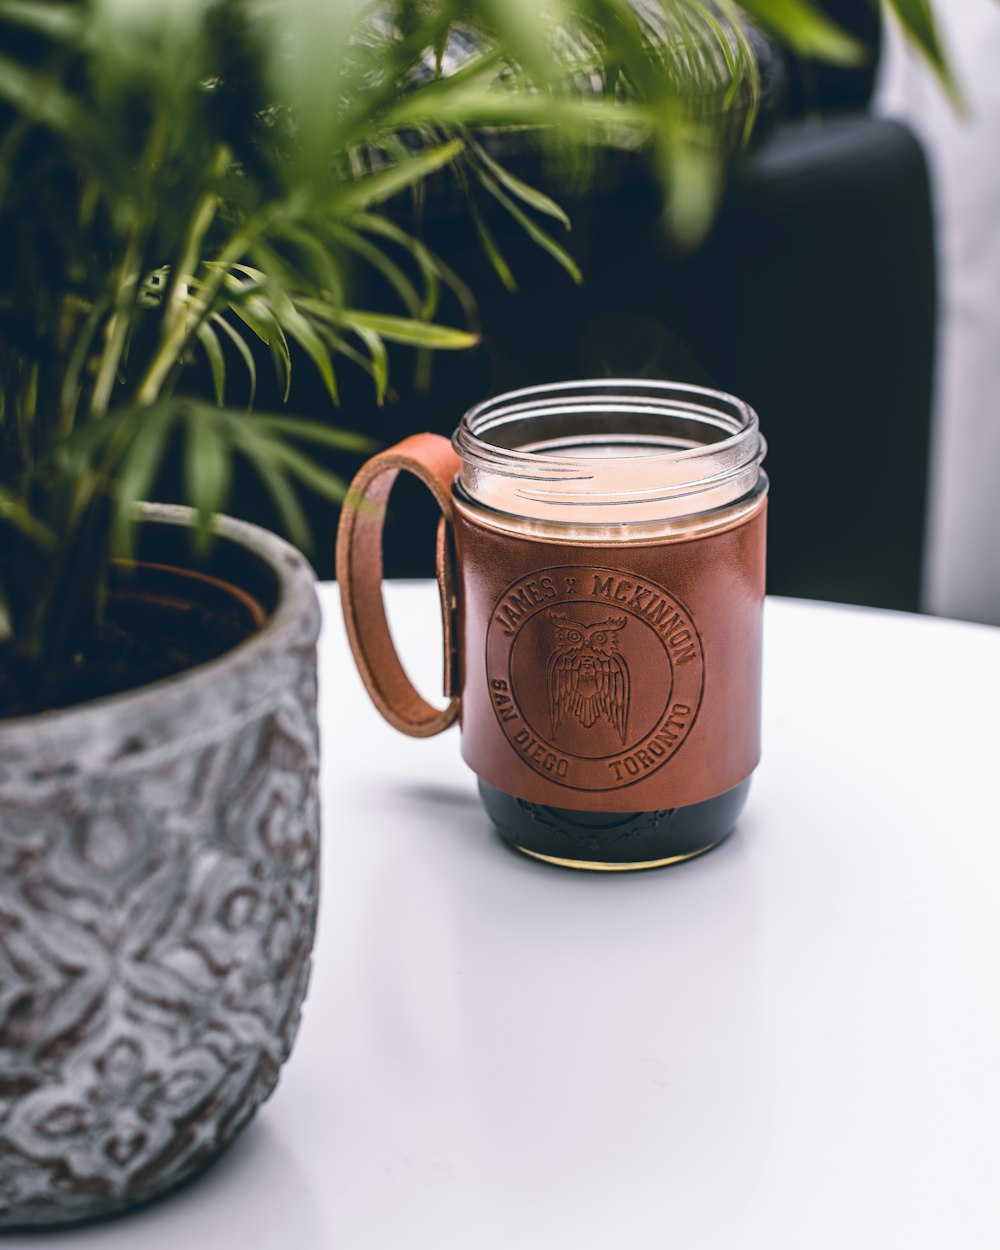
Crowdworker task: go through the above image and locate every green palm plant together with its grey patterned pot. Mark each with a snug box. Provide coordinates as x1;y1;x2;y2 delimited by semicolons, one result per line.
0;0;955;1226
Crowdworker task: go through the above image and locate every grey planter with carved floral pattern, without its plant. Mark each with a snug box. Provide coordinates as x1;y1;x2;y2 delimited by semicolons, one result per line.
0;506;319;1228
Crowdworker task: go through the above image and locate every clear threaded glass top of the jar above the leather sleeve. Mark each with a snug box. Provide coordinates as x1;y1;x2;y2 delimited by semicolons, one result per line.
453;379;766;524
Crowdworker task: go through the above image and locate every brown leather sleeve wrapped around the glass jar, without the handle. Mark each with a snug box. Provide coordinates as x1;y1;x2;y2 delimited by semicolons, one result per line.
455;500;766;811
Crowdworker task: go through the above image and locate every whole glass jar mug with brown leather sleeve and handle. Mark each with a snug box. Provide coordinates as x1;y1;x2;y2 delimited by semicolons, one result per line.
338;380;768;870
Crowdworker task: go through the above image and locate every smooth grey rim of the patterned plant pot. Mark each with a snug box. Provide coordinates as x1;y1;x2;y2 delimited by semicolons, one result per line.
0;504;320;765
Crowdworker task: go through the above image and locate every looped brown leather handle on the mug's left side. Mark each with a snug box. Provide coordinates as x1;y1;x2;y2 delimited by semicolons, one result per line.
336;434;461;738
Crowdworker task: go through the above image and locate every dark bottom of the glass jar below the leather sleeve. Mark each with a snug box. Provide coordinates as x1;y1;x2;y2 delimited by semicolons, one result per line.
479;778;750;873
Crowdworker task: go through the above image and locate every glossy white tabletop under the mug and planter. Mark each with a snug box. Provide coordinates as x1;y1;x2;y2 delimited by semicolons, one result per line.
13;584;1000;1250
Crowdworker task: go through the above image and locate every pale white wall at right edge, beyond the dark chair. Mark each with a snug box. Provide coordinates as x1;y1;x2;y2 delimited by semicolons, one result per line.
876;0;1000;624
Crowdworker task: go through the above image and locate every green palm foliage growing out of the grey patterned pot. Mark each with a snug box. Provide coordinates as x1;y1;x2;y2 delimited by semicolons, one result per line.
0;0;958;675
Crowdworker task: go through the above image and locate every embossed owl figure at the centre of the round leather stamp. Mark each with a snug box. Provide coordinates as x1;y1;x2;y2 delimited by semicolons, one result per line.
545;611;629;746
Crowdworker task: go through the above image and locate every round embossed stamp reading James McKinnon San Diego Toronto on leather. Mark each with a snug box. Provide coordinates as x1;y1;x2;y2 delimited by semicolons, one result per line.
486;565;705;790
